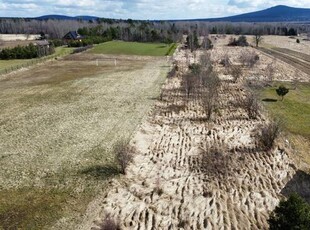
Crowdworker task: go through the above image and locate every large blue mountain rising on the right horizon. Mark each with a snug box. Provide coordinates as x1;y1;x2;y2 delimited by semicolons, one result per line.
191;5;310;22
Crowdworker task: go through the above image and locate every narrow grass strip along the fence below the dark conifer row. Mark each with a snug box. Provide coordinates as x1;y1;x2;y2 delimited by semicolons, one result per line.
0;47;72;73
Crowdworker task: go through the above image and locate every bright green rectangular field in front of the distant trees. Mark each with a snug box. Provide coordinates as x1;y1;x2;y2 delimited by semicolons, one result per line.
89;41;176;56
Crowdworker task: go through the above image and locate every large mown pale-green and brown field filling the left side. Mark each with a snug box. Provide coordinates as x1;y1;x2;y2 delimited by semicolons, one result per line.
0;51;169;229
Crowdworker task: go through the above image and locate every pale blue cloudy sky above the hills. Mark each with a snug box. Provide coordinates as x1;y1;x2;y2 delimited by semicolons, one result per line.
0;0;310;19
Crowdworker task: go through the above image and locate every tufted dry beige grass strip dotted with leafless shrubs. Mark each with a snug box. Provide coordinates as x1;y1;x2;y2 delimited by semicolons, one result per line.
79;38;308;230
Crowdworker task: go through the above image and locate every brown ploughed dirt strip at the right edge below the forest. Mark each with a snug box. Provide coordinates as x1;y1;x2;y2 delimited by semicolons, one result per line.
258;47;310;75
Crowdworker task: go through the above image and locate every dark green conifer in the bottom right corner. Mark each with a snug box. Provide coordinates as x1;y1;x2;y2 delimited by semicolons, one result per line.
268;193;310;230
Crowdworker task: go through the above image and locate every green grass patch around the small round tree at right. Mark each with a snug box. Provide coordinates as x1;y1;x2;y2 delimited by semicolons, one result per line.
261;82;310;164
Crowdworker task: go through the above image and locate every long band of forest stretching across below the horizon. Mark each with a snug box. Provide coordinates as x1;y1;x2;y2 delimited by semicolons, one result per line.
0;18;310;42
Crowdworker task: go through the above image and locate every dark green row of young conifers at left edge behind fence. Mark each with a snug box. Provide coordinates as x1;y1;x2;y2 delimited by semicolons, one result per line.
0;43;55;60
